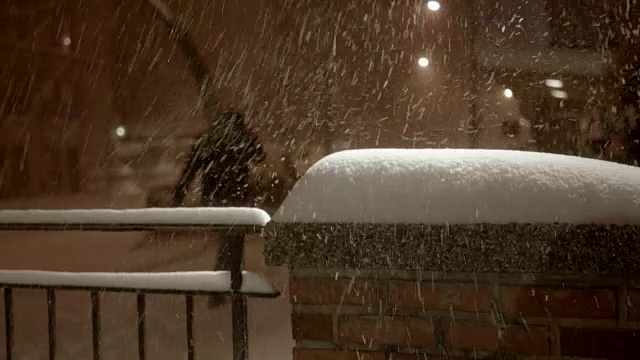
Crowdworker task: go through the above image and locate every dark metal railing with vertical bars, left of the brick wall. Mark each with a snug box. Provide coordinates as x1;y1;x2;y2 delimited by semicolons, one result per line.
0;209;279;360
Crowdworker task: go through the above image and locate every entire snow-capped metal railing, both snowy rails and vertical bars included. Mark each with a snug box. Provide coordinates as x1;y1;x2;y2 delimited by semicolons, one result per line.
0;208;279;360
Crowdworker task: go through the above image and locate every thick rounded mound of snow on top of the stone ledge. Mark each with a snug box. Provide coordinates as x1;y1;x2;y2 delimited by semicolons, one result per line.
273;149;640;224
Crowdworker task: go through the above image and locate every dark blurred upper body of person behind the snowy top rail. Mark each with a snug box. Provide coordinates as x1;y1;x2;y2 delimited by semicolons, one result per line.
173;112;265;206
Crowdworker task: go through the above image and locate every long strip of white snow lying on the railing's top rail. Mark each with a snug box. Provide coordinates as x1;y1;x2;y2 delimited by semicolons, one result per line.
0;207;270;226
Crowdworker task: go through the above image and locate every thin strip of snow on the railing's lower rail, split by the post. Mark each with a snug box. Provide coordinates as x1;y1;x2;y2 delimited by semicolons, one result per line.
0;270;278;294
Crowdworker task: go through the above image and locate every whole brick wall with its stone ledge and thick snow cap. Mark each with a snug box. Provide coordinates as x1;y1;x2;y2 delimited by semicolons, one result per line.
265;149;640;360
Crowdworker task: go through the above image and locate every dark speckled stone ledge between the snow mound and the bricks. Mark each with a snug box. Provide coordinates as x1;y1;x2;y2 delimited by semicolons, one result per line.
265;222;640;276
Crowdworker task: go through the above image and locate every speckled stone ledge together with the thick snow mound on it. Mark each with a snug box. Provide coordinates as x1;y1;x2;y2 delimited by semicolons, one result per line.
265;150;640;276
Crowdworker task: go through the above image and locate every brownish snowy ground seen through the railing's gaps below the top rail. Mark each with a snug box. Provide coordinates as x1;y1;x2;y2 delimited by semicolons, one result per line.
0;197;293;360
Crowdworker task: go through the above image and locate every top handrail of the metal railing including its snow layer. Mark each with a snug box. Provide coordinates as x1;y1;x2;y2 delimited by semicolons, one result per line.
0;207;270;231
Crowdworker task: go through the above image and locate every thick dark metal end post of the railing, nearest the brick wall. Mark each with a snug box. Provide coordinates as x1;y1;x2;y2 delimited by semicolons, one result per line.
227;234;249;360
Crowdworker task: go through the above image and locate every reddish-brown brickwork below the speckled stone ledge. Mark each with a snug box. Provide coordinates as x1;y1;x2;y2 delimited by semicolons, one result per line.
290;270;640;360
